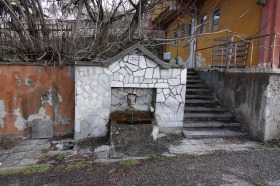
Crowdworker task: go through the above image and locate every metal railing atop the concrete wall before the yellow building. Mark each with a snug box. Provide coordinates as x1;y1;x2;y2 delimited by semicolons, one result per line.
196;33;280;68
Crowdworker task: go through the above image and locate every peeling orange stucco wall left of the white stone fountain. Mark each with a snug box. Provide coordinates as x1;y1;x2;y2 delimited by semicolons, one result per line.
0;65;75;136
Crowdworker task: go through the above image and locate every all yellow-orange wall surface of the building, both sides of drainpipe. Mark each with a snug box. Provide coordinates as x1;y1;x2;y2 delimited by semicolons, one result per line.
161;0;263;66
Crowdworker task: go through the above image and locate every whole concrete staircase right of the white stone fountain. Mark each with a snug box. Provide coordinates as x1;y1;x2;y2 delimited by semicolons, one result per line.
183;70;247;138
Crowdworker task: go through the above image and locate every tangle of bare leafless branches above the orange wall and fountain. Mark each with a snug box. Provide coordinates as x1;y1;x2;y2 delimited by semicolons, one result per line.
0;0;162;65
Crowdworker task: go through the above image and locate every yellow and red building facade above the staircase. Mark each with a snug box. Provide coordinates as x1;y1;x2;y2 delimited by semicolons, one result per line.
152;0;280;68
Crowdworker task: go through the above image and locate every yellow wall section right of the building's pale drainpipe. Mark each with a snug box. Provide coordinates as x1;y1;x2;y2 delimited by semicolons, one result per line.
196;0;262;66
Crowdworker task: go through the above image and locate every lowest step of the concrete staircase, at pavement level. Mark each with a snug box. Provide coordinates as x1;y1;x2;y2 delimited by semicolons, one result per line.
183;129;247;138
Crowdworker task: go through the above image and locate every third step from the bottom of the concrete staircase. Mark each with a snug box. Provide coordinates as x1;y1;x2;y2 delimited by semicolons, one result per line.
184;113;234;121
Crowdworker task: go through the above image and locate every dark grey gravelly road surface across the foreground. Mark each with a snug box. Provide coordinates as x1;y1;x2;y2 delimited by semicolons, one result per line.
0;148;280;186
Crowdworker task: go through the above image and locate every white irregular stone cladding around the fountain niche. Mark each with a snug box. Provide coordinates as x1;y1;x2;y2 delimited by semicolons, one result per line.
75;50;187;140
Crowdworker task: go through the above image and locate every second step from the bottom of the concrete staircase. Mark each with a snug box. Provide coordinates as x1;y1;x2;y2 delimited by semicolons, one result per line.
184;121;241;128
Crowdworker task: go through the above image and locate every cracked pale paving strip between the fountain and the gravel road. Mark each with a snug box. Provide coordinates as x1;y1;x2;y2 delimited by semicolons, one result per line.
0;135;262;170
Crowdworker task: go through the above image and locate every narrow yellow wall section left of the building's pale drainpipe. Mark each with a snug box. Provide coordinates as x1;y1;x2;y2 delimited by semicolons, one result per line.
165;16;194;61
